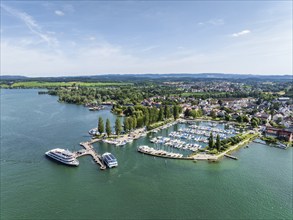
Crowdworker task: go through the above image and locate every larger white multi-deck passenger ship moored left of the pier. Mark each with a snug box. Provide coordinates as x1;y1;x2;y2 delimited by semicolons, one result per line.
45;148;79;166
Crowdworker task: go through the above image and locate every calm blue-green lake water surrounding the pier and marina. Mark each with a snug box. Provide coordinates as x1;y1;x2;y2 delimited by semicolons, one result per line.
1;90;293;219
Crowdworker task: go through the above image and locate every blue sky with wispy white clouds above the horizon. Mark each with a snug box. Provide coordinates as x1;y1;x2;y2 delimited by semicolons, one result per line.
0;0;293;77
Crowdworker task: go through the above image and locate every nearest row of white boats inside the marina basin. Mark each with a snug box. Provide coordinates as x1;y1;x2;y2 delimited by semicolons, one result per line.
150;136;201;152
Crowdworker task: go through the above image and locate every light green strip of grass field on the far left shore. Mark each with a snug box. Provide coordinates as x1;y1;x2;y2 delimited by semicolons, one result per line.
0;81;133;88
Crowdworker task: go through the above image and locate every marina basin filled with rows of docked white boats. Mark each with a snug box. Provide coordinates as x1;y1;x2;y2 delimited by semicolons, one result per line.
143;120;239;161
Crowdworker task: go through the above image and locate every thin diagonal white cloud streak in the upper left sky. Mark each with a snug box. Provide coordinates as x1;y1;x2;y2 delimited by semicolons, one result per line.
1;4;58;46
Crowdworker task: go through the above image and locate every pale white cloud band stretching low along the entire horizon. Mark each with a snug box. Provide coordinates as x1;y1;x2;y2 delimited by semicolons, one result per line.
1;33;292;76
